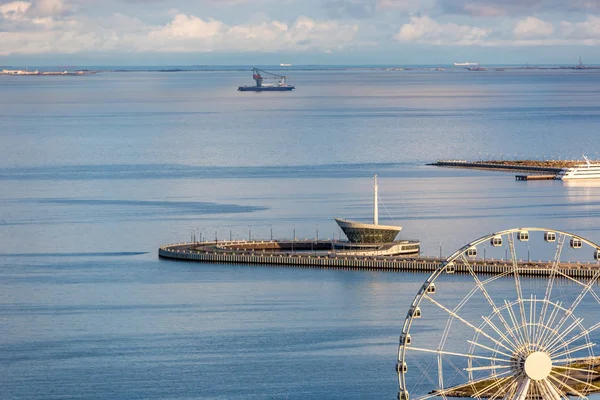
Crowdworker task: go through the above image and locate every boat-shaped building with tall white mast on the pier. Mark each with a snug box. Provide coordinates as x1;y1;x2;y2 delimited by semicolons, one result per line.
334;175;402;244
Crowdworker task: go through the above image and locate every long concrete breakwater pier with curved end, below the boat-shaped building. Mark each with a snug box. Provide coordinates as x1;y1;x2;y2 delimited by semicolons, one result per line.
158;241;598;278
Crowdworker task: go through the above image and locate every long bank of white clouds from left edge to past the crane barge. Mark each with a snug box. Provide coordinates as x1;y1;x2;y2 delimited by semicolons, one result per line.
0;0;358;55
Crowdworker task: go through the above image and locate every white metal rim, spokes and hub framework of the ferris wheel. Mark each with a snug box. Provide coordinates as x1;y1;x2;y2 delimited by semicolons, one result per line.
396;227;600;400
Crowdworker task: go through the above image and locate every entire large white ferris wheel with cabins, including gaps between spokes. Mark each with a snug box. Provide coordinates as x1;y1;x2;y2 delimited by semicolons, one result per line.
396;228;600;400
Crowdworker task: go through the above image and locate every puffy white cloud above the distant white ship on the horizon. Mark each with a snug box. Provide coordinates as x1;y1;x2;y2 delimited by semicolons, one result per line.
394;16;491;46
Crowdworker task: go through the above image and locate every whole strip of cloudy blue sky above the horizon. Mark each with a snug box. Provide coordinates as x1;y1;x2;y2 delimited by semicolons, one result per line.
0;0;600;65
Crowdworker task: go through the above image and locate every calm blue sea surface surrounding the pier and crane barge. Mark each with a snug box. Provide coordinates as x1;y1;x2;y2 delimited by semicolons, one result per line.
0;70;600;400
